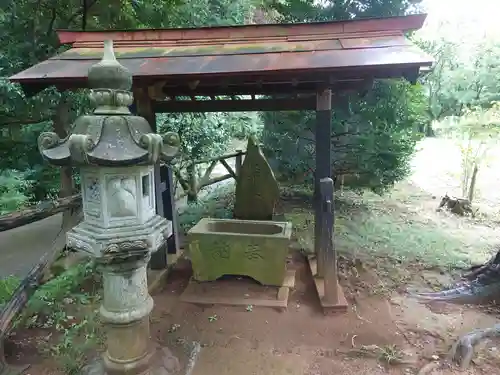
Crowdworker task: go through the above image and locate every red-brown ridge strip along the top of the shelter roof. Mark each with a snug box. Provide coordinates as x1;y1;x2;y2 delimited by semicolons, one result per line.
57;14;427;44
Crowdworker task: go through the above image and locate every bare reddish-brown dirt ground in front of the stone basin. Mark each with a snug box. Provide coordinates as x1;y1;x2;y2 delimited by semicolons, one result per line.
146;253;500;375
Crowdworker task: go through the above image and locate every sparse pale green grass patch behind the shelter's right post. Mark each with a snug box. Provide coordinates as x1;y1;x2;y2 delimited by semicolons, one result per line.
286;186;486;270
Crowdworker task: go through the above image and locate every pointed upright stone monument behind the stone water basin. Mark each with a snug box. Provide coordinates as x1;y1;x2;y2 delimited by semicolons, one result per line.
234;137;280;220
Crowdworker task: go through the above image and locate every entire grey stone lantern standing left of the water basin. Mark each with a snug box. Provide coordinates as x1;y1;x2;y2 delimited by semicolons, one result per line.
38;40;180;375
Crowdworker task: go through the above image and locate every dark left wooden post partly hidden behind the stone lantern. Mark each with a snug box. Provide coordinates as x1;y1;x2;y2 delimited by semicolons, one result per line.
131;89;179;270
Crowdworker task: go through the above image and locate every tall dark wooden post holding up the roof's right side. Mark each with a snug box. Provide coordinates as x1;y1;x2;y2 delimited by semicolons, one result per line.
314;90;332;277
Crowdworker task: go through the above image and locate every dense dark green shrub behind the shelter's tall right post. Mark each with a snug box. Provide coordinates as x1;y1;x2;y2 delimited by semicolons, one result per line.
264;81;427;192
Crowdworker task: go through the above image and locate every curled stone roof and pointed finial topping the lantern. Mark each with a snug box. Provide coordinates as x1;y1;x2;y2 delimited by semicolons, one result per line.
38;40;180;167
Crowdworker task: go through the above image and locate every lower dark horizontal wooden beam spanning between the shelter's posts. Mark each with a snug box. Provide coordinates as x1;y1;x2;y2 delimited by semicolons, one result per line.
152;96;316;113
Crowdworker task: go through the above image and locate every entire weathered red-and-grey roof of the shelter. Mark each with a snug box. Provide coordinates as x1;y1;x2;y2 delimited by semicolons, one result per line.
10;15;432;96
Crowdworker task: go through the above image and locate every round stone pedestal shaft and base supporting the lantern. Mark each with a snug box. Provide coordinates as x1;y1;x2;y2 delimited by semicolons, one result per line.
83;254;180;375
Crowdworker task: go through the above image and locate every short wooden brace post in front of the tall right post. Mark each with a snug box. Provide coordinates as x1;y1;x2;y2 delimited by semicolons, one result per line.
319;177;338;305
